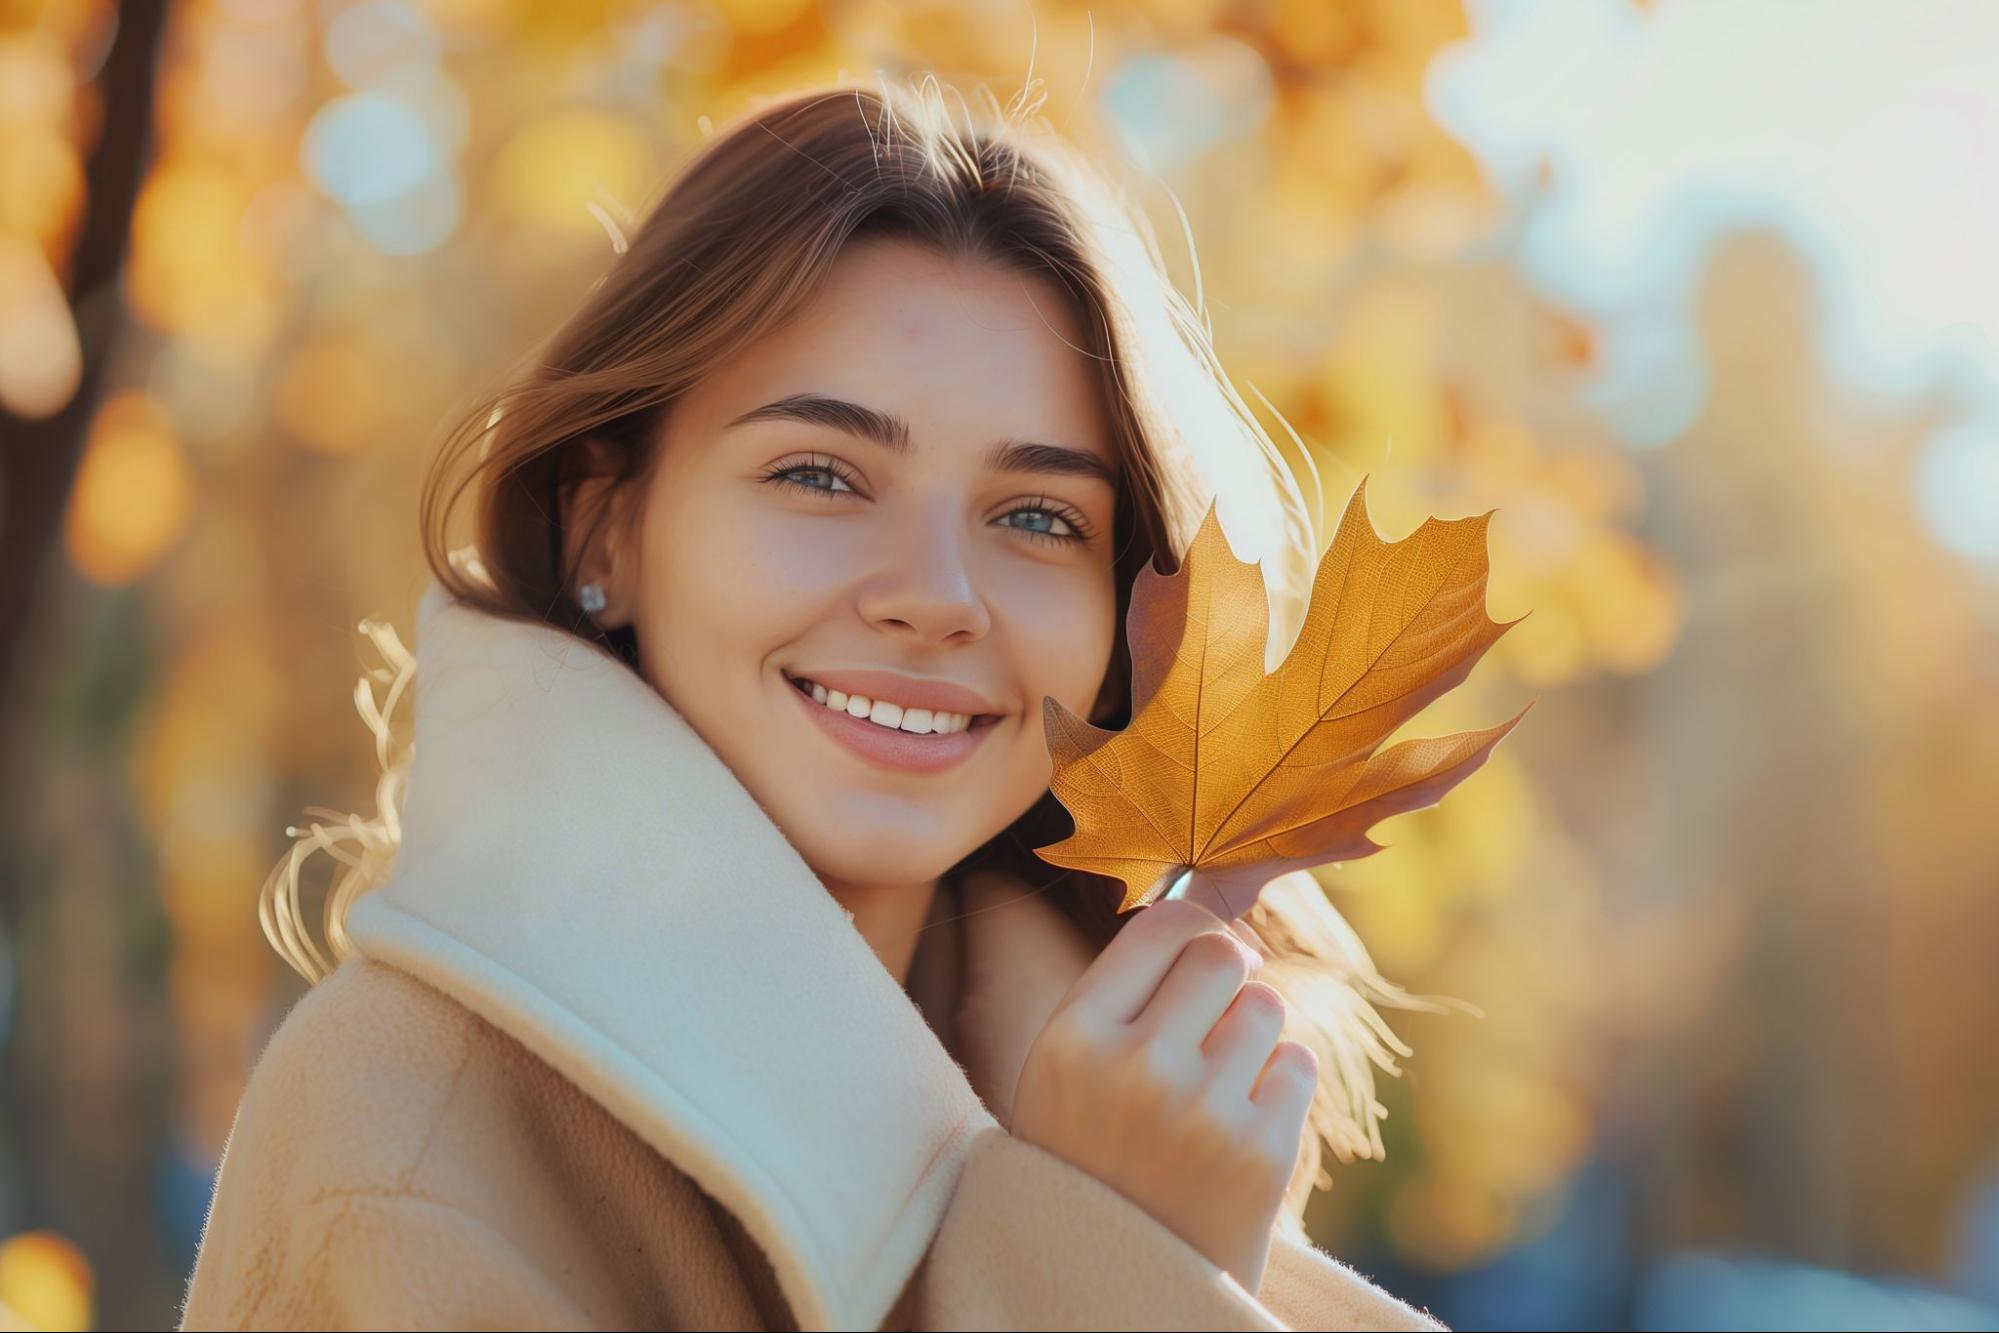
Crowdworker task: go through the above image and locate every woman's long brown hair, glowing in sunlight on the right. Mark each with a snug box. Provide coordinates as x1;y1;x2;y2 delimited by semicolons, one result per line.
262;86;1437;1187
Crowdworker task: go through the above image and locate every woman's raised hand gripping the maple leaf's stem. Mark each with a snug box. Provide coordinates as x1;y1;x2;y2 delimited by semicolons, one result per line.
1009;899;1319;1295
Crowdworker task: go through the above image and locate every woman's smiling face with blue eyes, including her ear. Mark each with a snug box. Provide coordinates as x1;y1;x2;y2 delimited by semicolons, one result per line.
598;240;1117;885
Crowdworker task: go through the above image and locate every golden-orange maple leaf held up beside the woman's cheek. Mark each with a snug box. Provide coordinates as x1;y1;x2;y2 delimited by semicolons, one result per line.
1035;478;1533;917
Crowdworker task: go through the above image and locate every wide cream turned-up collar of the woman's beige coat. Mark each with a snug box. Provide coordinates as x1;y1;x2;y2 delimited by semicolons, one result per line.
346;582;1087;1329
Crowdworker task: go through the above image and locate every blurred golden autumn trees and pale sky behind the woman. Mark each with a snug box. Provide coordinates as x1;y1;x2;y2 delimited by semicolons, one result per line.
0;0;1999;1329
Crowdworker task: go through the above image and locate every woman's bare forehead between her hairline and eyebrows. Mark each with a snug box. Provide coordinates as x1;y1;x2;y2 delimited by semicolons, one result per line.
704;240;1115;462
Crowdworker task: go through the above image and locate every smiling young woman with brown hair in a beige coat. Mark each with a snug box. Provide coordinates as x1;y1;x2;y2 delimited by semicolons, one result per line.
182;88;1441;1329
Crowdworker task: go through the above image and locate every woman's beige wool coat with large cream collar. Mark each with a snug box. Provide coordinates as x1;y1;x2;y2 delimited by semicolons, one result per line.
182;584;1443;1329
